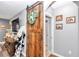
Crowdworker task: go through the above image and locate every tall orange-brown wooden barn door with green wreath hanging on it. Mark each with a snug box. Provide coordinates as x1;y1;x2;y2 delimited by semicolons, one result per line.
26;2;43;57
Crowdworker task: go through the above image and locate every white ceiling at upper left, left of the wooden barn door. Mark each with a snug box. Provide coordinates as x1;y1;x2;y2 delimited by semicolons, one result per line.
0;0;36;19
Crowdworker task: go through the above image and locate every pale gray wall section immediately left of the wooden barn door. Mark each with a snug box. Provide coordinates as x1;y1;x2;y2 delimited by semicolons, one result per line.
10;9;27;56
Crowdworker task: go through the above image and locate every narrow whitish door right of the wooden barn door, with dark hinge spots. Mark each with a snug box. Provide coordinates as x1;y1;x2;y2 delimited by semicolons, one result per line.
45;16;53;52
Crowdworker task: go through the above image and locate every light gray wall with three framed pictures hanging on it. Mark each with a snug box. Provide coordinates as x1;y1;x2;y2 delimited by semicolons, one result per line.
54;2;79;57
